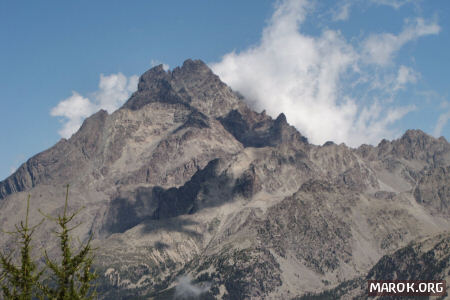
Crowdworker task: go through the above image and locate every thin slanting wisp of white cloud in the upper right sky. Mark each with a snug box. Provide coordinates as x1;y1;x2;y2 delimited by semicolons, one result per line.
363;18;440;65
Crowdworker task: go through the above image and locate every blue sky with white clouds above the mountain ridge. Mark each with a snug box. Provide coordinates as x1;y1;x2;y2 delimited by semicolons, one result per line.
0;0;450;180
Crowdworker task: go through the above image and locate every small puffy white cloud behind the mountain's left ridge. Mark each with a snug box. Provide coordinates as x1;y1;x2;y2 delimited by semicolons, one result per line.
50;73;138;138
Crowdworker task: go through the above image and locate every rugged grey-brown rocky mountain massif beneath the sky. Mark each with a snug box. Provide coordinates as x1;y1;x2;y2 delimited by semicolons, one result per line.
0;60;450;299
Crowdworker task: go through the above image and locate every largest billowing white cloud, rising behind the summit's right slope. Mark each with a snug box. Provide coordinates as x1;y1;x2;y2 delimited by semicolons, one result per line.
211;0;428;146
